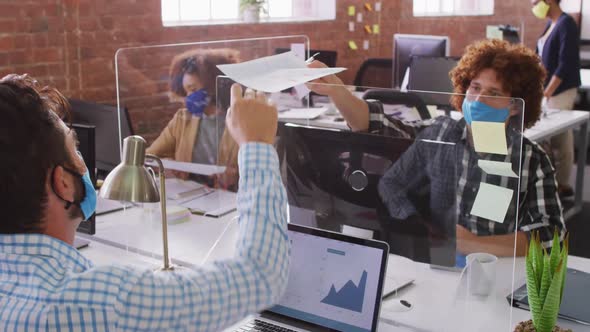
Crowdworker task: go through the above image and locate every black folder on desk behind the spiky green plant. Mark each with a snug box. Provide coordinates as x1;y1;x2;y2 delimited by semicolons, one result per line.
506;269;590;325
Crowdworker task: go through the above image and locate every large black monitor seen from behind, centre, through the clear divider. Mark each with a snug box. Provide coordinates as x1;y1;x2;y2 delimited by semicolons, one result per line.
278;124;455;266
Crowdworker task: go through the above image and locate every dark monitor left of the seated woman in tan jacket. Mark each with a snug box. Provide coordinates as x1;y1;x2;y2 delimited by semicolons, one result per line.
69;99;133;172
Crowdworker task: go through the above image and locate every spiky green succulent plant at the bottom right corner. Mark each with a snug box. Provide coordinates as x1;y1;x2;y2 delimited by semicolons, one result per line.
514;231;571;332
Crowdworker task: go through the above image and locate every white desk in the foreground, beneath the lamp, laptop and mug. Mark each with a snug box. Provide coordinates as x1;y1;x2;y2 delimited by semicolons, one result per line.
81;207;590;331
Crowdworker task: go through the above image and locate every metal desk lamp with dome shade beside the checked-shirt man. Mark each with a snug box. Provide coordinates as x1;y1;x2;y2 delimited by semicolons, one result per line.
100;136;174;271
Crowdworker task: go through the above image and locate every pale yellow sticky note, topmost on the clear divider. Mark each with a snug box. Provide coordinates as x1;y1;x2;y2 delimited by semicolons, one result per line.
471;121;508;155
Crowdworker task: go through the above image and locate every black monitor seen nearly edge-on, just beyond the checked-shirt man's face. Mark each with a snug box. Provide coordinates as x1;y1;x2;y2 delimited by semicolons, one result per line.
72;123;96;234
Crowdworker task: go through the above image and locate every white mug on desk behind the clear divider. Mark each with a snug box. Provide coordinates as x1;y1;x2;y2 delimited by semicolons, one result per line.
466;252;498;296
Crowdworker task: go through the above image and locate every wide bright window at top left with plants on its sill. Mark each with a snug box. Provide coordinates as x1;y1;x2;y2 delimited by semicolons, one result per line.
160;0;338;27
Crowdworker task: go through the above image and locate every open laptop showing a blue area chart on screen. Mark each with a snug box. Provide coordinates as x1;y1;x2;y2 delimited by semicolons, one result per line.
236;224;389;332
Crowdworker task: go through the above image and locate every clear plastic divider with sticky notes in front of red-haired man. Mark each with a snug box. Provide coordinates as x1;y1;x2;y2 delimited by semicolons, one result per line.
218;77;539;331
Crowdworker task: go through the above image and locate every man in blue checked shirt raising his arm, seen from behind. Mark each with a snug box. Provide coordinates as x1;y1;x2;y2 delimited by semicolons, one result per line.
0;75;290;331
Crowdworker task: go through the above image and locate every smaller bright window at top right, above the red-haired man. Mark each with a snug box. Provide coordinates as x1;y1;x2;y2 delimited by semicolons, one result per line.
414;0;494;16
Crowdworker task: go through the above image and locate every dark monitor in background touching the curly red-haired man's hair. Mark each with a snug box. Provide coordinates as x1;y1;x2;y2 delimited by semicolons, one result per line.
408;55;459;110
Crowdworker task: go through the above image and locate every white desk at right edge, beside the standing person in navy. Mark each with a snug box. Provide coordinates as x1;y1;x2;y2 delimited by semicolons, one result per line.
524;110;590;220
